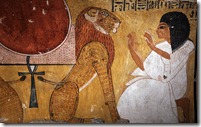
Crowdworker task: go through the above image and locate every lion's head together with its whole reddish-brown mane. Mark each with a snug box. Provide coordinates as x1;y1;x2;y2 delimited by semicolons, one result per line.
75;7;121;68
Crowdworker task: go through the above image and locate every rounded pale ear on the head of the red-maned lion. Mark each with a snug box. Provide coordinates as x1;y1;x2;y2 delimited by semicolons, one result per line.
84;9;98;22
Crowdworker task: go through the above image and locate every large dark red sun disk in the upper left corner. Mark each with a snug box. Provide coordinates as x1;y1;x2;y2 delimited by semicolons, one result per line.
0;0;70;54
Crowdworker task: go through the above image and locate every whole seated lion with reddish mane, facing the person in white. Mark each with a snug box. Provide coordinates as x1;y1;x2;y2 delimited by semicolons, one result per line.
50;7;128;123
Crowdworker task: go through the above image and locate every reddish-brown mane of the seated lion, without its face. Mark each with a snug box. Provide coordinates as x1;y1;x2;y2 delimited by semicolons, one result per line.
75;7;114;68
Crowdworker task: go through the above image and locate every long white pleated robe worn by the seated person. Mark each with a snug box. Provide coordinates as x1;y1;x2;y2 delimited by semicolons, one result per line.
117;40;194;123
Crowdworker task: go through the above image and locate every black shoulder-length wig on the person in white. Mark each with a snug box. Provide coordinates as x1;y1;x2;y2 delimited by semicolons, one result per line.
160;12;190;52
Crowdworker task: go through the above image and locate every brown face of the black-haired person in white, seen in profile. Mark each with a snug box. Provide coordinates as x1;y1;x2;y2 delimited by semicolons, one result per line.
156;22;170;43
